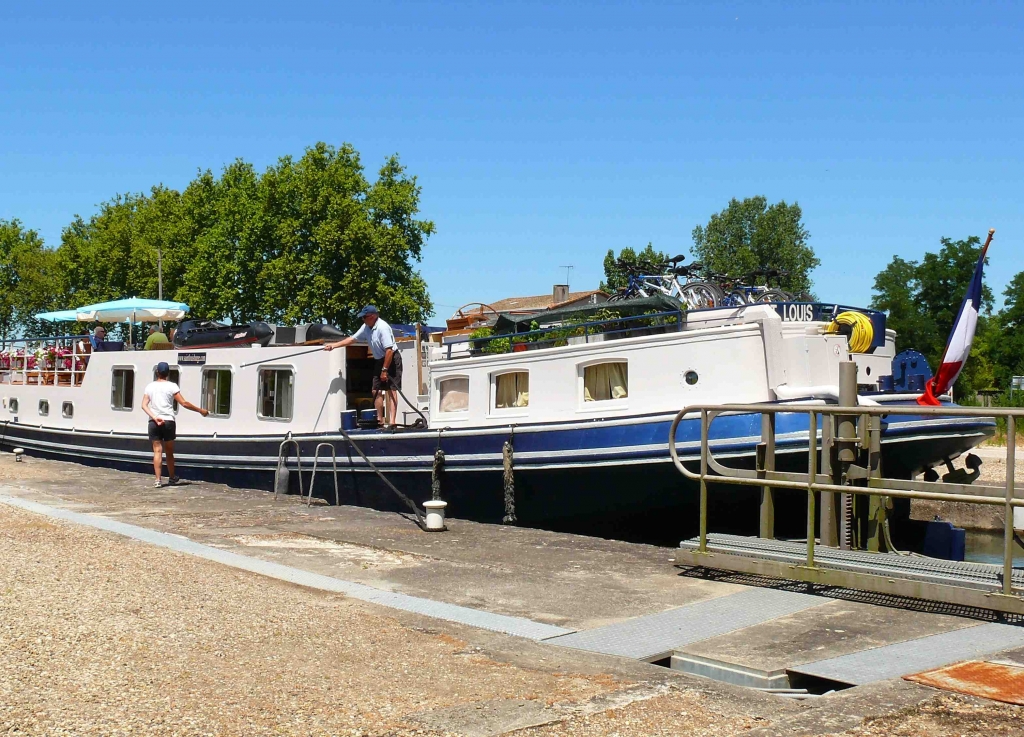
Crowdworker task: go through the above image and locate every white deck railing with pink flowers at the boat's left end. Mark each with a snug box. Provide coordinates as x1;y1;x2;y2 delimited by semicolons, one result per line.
0;335;90;386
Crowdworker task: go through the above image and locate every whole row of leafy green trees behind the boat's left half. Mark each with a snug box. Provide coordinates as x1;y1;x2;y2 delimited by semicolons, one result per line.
0;143;434;336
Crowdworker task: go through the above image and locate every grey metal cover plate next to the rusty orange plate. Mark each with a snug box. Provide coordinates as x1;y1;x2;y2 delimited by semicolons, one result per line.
788;624;1024;686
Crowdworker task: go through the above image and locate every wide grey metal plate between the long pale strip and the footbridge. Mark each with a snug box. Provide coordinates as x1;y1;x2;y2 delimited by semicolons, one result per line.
546;589;833;660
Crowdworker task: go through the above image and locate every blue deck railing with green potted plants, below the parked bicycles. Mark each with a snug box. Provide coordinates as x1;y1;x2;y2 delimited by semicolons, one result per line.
444;308;685;358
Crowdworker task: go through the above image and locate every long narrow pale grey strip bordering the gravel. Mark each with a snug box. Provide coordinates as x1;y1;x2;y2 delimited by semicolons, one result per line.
0;494;572;640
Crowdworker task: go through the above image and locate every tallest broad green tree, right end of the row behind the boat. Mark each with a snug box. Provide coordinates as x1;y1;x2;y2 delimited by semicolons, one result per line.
178;143;434;329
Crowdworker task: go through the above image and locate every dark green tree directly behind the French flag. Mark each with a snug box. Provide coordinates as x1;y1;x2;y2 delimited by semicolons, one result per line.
871;235;997;396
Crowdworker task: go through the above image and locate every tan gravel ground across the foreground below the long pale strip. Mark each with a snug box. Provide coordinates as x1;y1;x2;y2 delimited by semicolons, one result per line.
0;465;1024;737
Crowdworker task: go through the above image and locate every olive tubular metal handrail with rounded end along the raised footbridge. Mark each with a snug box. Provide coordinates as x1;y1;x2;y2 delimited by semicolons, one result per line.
669;403;1024;596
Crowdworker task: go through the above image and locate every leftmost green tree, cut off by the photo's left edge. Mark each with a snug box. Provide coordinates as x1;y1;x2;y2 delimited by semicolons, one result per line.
0;219;56;342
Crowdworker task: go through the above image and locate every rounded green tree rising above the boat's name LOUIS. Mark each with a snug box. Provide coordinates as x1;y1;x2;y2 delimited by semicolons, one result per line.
692;196;820;294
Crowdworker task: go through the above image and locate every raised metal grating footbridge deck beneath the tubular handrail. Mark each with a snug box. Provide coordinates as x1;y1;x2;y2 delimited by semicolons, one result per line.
679;534;1024;591
